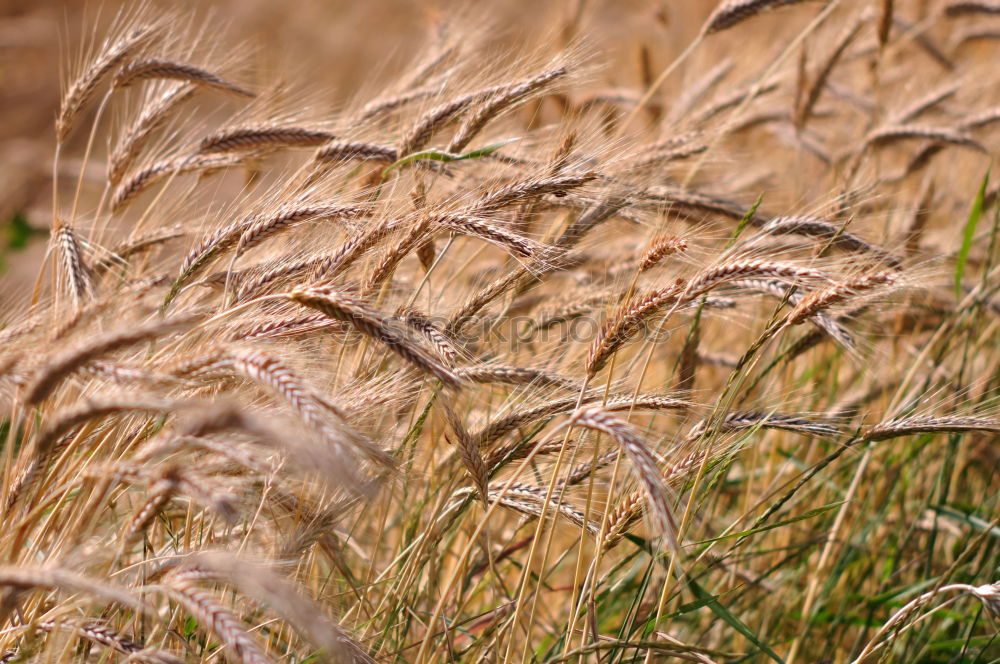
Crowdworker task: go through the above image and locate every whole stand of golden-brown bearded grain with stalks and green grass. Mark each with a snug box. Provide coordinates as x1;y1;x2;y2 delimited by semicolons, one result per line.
0;0;1000;664
